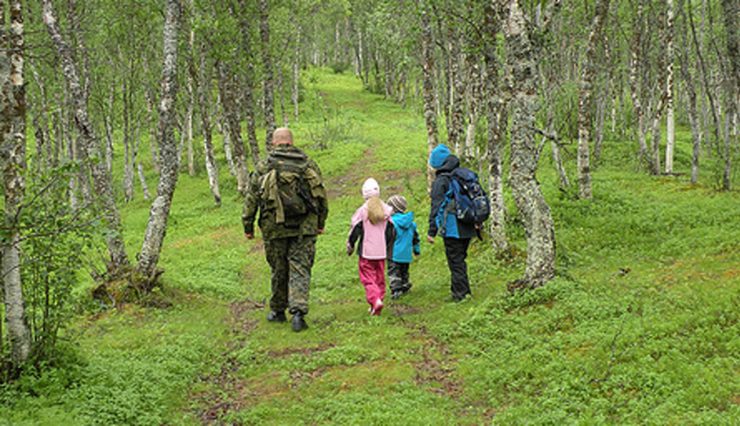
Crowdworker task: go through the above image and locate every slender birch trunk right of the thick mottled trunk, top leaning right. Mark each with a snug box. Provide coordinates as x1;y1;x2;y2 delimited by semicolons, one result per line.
578;0;609;200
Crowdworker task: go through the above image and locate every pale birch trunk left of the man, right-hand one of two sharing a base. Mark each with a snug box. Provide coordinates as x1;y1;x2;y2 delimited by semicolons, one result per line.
138;0;182;286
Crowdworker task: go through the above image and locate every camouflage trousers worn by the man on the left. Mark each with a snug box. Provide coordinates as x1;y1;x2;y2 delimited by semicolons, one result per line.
265;235;316;315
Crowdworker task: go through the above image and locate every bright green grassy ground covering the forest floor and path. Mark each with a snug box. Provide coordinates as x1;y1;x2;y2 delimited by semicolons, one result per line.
0;70;740;425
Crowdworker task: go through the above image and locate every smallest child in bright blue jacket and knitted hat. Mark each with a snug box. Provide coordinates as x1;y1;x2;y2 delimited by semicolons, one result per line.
387;195;421;299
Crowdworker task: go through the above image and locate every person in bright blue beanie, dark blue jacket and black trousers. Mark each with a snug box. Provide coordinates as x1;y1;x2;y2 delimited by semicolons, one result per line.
427;145;477;302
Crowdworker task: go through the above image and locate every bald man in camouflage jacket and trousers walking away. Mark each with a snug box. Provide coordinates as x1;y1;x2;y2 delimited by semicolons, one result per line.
242;128;329;331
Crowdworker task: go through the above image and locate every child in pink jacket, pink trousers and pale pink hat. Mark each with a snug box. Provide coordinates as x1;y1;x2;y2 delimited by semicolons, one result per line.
347;178;395;315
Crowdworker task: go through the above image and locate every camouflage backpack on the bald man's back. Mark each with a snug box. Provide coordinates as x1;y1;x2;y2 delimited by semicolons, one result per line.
262;150;323;227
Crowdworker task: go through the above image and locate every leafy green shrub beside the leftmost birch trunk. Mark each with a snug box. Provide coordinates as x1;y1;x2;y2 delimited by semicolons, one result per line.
3;163;100;369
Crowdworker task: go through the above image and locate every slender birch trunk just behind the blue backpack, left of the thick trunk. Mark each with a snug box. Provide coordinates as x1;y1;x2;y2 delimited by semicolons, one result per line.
484;2;509;251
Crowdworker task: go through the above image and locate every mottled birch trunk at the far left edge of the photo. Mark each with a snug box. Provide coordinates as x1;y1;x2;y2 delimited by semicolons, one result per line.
0;0;31;367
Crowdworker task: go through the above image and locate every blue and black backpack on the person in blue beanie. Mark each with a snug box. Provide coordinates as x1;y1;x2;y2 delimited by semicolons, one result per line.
447;167;491;224
